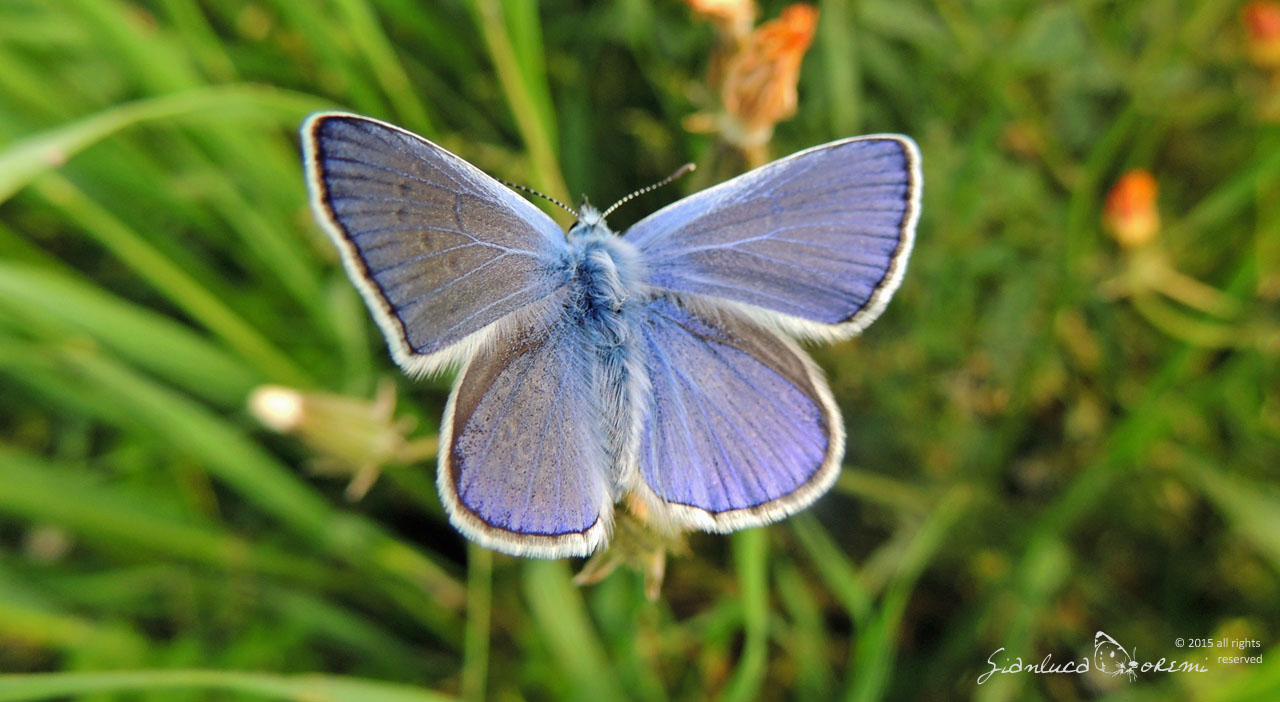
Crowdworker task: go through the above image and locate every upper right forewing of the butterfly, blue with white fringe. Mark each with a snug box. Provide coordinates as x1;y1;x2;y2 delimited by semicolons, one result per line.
626;135;920;338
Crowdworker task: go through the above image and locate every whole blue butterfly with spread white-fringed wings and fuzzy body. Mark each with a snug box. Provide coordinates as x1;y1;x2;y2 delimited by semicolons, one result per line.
302;113;920;559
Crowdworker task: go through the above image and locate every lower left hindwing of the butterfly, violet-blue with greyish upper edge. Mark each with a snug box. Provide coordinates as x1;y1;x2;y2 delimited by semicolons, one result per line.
436;303;613;559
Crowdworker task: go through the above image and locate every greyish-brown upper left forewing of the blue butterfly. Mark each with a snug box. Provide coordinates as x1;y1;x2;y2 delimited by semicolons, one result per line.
302;113;568;375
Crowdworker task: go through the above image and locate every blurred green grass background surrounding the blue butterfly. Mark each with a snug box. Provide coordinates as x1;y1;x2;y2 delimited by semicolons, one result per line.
0;0;1280;702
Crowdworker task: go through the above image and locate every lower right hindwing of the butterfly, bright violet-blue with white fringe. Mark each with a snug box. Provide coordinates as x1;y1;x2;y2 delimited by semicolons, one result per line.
637;297;845;532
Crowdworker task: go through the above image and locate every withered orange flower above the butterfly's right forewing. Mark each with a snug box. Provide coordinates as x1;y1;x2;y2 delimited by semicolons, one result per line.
721;4;818;147
